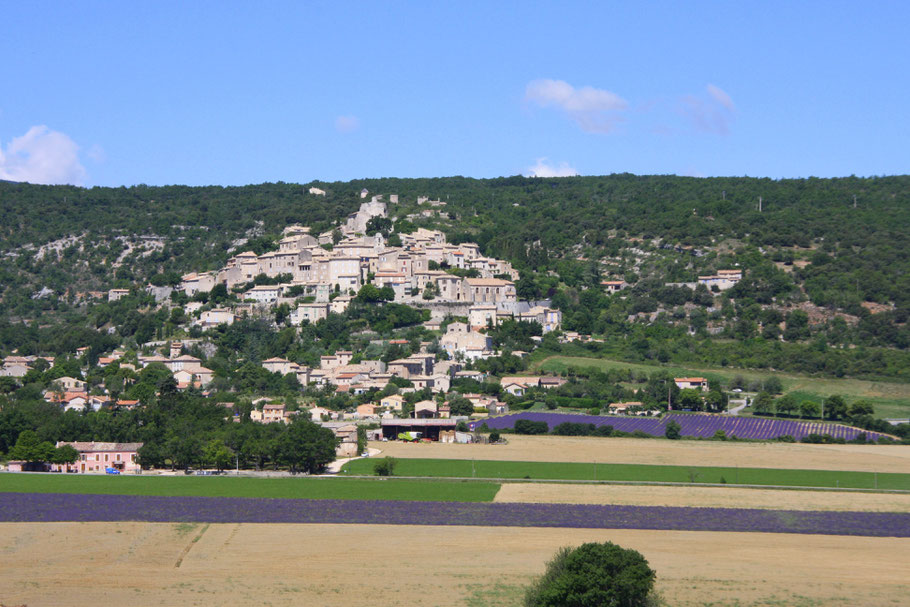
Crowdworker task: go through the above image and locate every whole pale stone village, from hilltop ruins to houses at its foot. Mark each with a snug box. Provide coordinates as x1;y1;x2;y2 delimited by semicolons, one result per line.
3;196;565;464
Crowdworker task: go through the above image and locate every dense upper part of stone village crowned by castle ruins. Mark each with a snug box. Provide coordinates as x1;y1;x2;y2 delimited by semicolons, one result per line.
180;196;560;334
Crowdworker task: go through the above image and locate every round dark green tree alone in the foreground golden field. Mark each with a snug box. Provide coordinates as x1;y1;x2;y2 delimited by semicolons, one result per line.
525;542;655;607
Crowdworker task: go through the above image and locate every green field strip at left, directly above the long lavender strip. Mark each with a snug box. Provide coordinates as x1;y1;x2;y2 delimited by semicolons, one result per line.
0;476;499;502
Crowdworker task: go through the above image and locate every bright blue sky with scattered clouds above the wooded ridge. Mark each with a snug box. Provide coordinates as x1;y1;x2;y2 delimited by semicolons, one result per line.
0;0;910;186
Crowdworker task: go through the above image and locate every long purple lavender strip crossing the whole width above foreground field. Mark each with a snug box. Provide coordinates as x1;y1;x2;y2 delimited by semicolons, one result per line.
0;493;910;537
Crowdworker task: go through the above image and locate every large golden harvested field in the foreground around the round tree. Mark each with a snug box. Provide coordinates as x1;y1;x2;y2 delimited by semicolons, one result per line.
0;523;910;607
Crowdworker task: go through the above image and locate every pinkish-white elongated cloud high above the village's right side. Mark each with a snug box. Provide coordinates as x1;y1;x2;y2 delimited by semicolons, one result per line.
525;80;629;133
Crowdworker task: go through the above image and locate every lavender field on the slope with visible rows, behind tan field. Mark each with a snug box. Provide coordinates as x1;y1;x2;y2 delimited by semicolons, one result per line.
469;411;885;441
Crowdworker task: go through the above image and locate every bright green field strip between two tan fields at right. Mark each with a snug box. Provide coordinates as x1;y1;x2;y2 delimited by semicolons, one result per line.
342;458;910;491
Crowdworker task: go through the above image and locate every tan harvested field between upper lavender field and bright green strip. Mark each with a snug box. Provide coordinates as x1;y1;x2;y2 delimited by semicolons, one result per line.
370;435;910;472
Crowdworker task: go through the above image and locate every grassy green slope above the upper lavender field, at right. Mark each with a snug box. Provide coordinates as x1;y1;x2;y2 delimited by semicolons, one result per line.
533;356;910;418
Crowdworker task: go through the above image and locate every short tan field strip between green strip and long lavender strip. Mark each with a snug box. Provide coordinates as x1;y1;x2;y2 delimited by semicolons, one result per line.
493;483;910;512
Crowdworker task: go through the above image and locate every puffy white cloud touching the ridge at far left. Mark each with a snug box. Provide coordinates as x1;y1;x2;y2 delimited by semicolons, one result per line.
0;125;86;185
